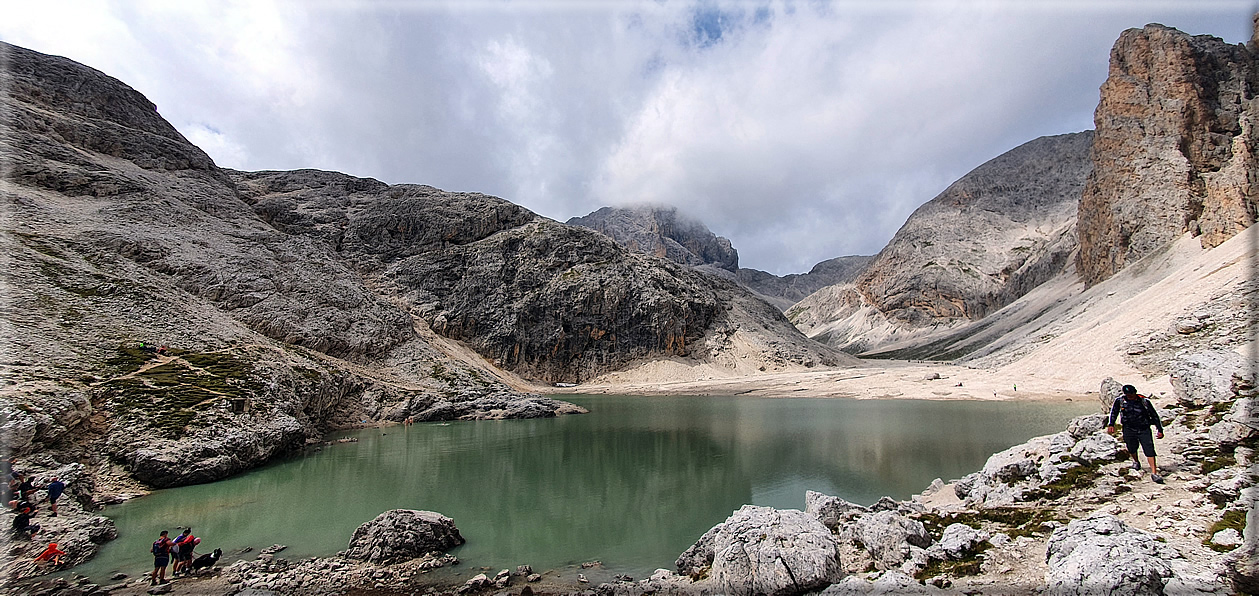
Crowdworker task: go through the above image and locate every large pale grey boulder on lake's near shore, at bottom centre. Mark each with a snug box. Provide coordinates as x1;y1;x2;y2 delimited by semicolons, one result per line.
677;505;841;595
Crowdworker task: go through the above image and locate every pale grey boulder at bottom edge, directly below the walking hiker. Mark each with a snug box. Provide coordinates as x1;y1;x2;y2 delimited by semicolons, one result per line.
1044;513;1180;596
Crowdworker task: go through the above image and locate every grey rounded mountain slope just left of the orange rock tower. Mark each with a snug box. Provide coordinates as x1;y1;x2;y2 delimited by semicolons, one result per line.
787;131;1093;353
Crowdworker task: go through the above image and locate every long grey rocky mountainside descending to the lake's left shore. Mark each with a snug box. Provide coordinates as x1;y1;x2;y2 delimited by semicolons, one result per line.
0;39;845;486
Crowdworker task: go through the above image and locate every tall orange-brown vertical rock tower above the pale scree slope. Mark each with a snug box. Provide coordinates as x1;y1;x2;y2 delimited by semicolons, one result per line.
1076;25;1259;284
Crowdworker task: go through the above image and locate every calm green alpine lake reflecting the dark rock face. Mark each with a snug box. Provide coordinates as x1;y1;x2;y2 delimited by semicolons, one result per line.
74;396;1099;580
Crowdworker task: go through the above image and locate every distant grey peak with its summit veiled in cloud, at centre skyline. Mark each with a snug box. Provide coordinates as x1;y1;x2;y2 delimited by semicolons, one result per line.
567;205;739;272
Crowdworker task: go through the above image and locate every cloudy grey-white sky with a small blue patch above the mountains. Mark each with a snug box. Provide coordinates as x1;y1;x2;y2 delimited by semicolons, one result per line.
0;0;1256;275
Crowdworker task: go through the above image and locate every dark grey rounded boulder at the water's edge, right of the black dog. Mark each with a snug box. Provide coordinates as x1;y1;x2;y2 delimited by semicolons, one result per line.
345;509;463;564
